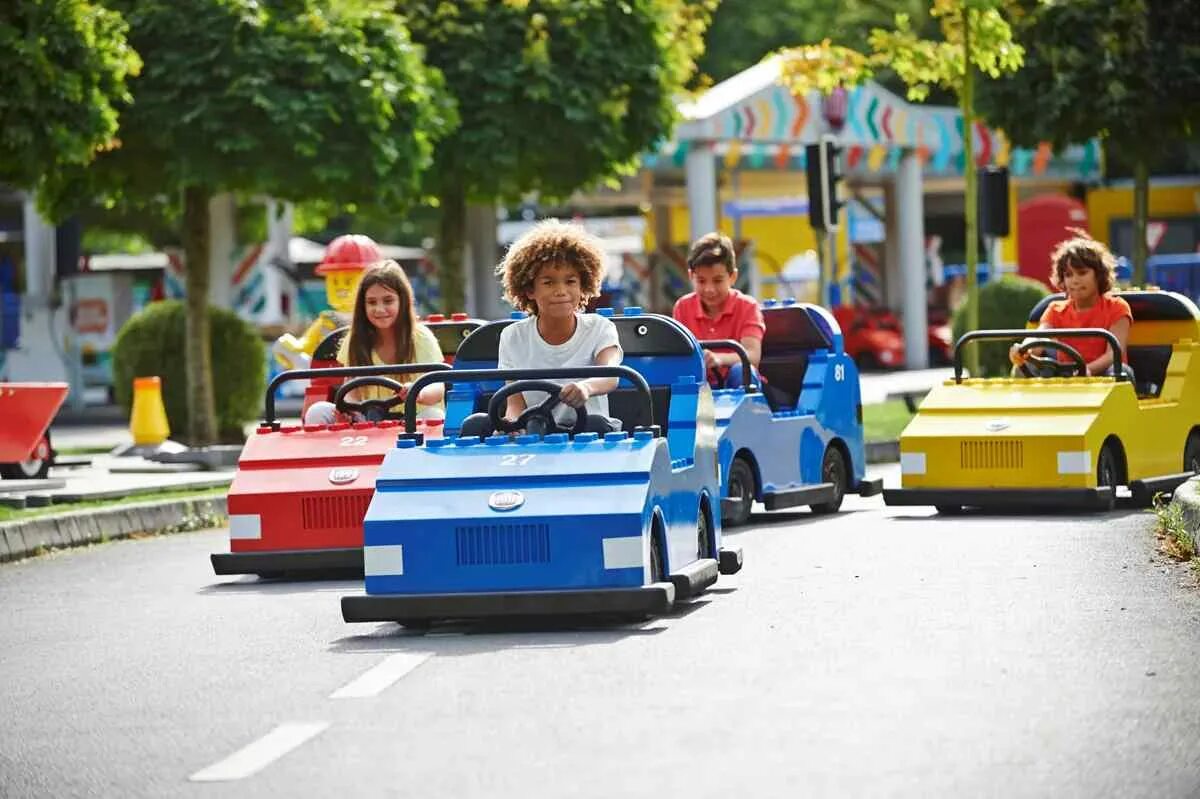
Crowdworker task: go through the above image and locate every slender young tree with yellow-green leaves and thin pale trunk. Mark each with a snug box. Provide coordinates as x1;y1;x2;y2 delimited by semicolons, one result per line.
784;0;1028;374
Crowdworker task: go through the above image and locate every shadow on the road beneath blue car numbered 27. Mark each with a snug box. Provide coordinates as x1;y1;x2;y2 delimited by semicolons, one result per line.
329;597;710;656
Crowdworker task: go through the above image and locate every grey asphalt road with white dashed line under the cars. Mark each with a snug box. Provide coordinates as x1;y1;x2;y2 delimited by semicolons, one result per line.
0;463;1200;799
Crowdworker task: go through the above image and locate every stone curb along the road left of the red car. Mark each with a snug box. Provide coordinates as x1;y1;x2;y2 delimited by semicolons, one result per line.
0;497;227;563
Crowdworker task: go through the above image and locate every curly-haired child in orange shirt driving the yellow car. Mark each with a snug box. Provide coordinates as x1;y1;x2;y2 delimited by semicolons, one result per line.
1008;230;1133;379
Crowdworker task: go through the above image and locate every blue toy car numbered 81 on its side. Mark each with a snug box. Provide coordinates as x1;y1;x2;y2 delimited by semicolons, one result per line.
701;300;883;527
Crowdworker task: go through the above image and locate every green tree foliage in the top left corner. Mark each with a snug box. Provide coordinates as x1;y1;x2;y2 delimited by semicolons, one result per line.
0;0;142;190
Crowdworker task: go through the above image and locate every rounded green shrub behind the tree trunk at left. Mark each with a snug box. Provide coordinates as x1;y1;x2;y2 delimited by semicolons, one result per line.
113;300;266;443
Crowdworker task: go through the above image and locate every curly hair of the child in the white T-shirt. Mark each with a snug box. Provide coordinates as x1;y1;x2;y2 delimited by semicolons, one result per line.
496;220;605;314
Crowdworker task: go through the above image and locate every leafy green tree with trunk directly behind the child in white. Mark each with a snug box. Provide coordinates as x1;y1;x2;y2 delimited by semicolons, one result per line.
400;0;712;311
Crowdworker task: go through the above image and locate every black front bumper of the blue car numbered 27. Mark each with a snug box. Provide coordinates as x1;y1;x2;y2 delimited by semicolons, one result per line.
342;583;676;624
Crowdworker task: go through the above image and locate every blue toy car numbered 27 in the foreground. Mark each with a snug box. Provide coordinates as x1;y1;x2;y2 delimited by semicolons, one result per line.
342;308;742;626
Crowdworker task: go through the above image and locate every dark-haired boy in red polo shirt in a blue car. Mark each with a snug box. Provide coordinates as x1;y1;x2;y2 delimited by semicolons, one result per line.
671;233;767;389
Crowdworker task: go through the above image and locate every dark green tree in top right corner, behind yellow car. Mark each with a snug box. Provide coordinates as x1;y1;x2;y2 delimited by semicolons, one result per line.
979;0;1200;283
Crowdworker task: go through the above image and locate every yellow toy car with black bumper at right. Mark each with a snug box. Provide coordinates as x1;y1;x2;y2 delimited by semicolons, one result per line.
883;290;1200;513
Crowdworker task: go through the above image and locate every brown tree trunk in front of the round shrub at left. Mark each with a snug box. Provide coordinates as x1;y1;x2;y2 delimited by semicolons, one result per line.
182;186;218;446
